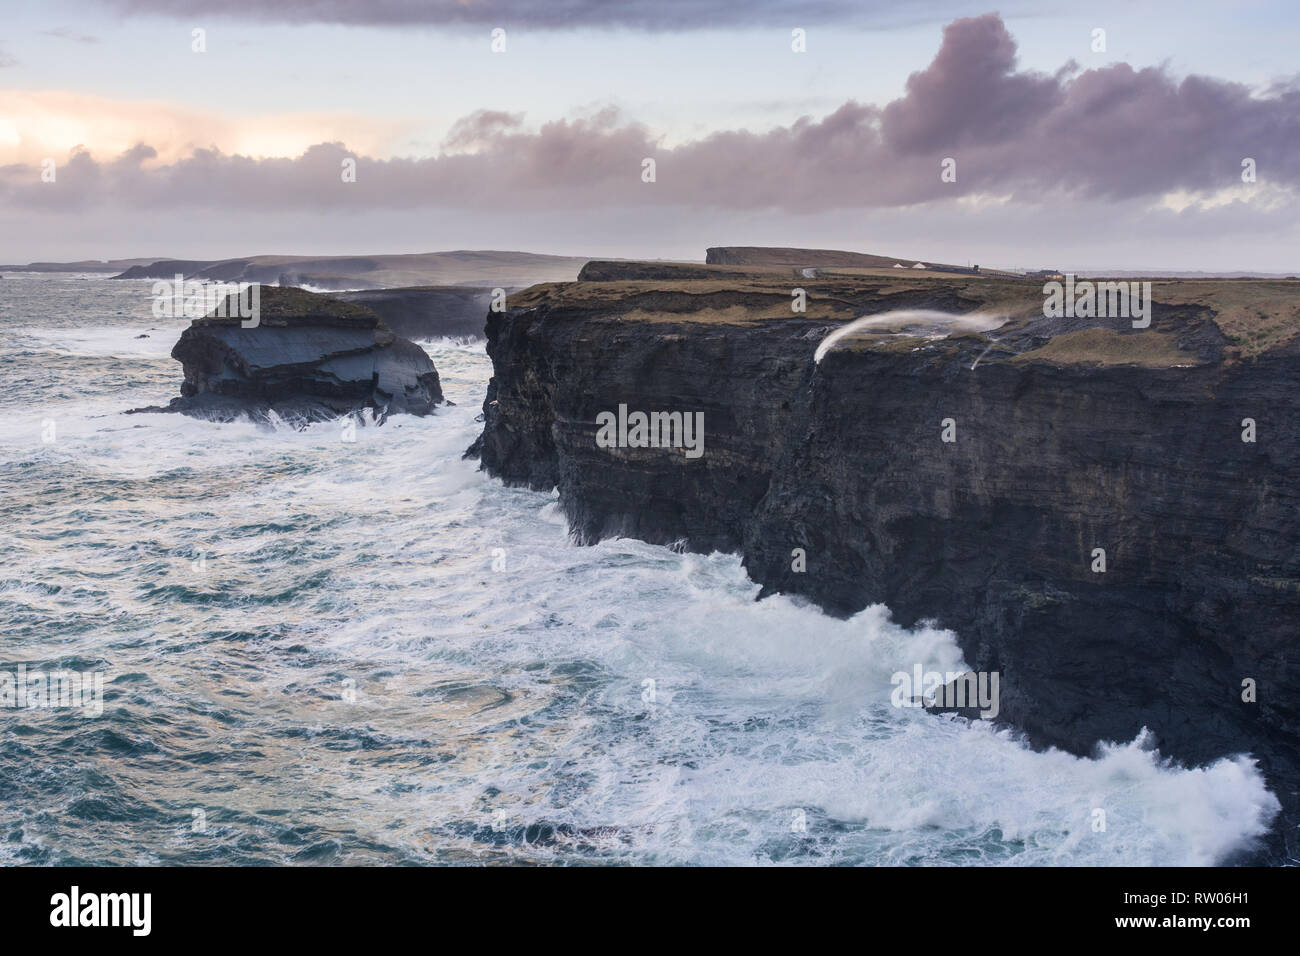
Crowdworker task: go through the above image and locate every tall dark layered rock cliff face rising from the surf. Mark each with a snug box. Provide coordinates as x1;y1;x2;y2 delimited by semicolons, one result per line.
471;273;1300;862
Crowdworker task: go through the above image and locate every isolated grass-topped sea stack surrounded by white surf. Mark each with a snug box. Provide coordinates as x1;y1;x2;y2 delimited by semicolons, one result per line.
133;287;443;423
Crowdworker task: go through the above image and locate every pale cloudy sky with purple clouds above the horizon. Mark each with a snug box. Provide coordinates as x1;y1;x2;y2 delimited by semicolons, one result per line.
0;0;1300;272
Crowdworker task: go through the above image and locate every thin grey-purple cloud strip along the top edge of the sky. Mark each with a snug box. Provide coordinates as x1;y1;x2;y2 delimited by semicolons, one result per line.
103;0;977;31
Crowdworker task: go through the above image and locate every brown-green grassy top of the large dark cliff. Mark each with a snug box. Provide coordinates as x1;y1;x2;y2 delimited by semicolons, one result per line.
510;263;1300;367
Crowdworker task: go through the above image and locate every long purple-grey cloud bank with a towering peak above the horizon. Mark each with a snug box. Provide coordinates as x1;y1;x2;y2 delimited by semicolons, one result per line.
0;14;1300;212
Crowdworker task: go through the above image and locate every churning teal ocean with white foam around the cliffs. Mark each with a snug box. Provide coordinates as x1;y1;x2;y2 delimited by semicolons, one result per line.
0;273;1277;865
